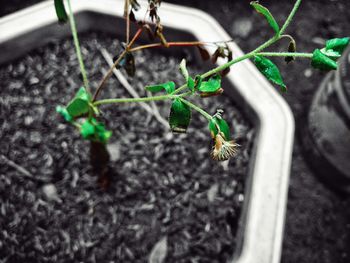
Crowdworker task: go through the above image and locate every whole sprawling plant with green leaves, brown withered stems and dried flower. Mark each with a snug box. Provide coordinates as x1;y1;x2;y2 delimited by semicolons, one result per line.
54;0;350;179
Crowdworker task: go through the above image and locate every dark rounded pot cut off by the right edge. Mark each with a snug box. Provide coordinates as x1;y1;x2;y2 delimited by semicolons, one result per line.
301;48;350;194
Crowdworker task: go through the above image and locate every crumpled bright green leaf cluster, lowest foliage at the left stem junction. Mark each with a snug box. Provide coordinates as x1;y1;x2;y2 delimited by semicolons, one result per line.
80;118;112;143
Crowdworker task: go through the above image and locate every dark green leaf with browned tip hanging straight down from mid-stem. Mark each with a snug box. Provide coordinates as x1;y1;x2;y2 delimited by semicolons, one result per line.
169;99;191;133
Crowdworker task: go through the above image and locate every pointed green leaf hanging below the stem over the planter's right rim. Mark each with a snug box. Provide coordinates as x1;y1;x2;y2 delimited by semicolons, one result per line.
254;56;287;92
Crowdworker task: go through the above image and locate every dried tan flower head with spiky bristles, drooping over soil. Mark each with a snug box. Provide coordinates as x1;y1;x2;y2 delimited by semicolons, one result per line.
211;132;239;161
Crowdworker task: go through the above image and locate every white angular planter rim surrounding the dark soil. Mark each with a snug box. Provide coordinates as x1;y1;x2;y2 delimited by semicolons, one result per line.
0;0;294;263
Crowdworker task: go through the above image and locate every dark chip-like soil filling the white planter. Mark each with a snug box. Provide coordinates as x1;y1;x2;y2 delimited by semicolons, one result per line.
0;34;254;262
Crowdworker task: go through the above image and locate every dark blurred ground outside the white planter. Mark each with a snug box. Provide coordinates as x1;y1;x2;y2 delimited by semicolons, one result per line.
0;0;350;263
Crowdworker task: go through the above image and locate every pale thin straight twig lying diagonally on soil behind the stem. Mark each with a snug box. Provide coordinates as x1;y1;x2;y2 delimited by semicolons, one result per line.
100;48;169;129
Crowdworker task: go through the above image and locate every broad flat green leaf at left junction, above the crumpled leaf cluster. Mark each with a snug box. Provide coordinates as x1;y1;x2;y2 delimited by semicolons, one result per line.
67;87;91;117
